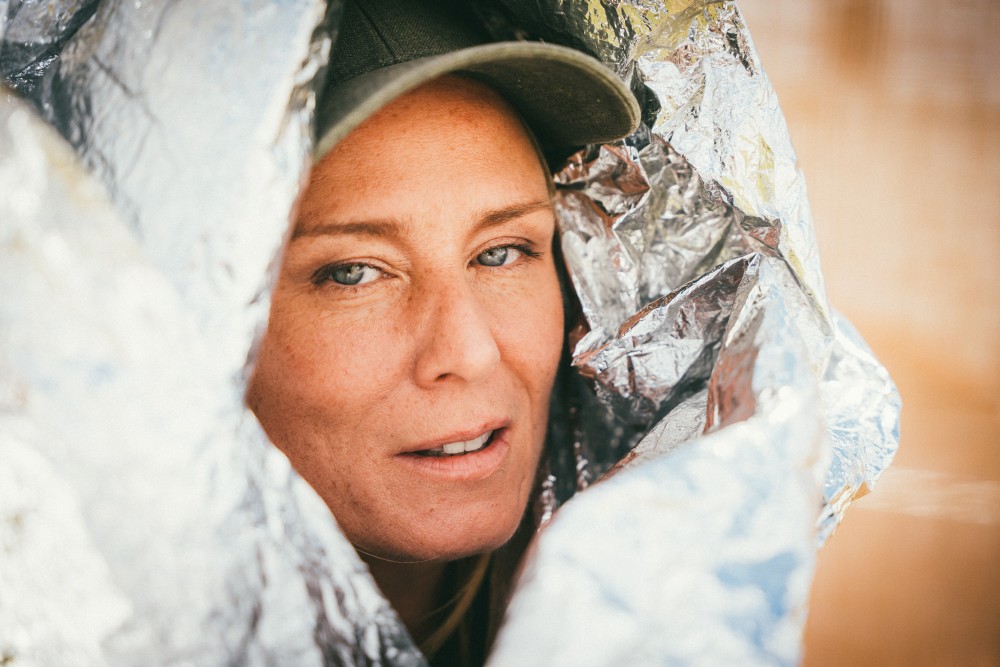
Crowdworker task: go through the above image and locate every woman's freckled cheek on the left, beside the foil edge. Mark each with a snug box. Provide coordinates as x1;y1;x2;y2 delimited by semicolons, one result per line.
247;301;401;520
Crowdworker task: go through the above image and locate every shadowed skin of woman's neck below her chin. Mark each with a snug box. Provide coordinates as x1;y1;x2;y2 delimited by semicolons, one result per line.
361;554;450;644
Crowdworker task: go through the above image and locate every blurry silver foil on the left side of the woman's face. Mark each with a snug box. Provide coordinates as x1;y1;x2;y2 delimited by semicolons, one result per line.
0;0;423;666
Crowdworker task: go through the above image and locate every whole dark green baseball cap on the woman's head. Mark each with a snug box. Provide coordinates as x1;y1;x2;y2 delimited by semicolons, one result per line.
315;0;639;159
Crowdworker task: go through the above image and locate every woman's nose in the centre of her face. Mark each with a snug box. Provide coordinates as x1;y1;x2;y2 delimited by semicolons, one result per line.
414;280;500;388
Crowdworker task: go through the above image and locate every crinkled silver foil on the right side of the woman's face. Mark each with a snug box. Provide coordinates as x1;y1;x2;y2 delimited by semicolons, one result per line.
491;2;899;665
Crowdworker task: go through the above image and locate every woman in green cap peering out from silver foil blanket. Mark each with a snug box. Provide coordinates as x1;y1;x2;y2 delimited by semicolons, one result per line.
248;2;638;663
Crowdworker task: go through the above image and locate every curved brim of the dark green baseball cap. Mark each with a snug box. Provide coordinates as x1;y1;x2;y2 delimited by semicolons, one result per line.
314;42;639;160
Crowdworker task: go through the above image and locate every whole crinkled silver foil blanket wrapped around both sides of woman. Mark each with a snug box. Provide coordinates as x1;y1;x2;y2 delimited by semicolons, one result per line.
0;0;899;665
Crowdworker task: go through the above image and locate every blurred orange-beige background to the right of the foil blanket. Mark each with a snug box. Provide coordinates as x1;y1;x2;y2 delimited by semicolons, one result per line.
739;0;1000;666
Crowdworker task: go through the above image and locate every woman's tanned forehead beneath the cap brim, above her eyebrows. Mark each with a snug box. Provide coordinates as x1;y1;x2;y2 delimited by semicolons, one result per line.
300;76;550;232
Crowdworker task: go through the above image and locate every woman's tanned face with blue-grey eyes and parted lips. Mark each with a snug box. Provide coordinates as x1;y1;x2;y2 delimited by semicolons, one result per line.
248;77;563;560
